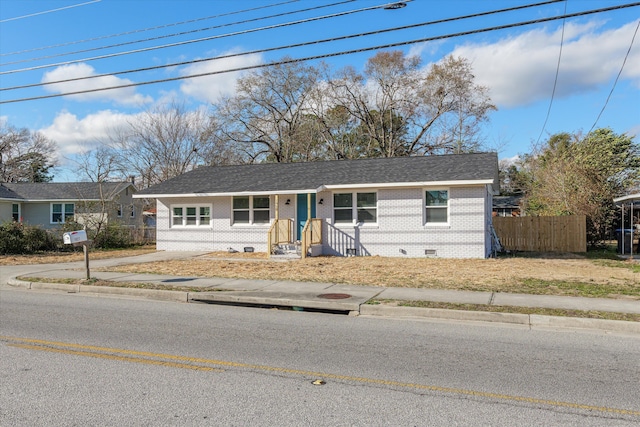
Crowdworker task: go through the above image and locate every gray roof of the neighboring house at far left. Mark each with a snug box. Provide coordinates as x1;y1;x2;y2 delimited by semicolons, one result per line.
0;182;133;201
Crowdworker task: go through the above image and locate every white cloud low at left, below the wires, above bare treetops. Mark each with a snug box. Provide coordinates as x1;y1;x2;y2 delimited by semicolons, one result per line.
39;110;134;161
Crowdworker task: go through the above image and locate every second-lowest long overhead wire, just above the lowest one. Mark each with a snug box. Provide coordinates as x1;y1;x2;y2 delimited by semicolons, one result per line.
0;0;564;91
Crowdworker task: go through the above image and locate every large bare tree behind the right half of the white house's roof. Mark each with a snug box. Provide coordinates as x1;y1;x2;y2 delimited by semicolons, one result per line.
330;51;495;157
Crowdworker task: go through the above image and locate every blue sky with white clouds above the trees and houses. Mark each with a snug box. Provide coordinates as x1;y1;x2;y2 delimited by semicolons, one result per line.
0;0;640;181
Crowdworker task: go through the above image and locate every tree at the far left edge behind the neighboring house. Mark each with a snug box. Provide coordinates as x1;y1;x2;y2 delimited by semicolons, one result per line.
0;123;57;182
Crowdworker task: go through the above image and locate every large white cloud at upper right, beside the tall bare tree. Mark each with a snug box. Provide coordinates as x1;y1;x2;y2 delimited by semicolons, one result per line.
452;22;640;107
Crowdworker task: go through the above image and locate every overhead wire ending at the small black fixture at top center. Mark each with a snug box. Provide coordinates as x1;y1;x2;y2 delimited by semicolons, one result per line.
0;2;408;75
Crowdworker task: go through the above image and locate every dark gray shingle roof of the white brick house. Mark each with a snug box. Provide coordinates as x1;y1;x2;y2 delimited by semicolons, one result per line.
137;153;499;197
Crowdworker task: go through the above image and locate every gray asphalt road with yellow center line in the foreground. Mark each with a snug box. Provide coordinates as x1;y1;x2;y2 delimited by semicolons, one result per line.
0;288;640;426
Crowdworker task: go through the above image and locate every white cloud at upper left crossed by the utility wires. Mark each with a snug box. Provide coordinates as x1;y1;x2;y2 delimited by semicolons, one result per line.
42;63;152;106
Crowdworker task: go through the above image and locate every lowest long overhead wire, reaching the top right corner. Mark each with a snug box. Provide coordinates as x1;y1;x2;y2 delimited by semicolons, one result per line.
0;2;640;104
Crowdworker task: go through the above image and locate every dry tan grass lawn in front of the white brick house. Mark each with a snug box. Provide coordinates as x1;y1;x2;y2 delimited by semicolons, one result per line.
102;252;640;299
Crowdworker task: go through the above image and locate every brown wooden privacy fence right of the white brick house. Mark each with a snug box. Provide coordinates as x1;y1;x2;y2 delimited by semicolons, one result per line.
493;215;587;252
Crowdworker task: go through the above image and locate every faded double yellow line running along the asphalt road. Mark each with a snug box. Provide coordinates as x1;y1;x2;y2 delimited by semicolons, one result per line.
0;336;640;416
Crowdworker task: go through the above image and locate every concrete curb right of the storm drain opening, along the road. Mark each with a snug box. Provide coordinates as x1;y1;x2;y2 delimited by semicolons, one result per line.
360;304;640;335
